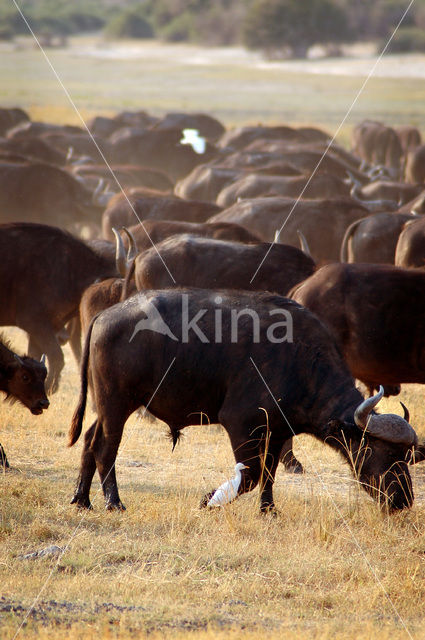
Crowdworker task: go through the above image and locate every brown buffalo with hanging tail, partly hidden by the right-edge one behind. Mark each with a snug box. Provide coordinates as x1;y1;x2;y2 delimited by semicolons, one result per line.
340;213;417;264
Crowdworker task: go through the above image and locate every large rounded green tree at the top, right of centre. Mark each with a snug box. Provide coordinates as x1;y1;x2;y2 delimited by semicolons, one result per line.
242;0;349;57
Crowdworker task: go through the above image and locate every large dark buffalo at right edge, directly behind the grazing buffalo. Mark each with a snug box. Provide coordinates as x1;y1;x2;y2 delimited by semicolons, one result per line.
290;264;425;395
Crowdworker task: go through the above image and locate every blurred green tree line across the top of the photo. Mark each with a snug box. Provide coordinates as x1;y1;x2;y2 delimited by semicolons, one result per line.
0;0;425;58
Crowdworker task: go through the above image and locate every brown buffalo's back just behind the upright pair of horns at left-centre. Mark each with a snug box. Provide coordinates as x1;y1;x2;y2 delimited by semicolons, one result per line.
102;192;221;241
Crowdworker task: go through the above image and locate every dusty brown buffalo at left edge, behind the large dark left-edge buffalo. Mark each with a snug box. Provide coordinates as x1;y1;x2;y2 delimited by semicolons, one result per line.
0;162;101;227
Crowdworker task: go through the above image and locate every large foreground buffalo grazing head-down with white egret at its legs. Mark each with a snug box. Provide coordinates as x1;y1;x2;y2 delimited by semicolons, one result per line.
69;289;417;511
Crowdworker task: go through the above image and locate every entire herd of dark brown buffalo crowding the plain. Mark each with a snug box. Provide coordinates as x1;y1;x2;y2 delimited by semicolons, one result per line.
0;108;425;512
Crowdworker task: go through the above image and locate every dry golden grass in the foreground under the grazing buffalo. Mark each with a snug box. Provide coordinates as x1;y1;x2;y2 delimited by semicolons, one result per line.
0;330;425;640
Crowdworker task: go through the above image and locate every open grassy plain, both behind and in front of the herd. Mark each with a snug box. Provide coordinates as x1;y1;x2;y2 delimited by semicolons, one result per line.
0;39;425;640
